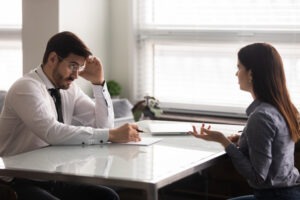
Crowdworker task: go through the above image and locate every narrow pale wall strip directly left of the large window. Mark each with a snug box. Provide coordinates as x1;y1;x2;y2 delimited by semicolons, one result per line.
109;0;134;100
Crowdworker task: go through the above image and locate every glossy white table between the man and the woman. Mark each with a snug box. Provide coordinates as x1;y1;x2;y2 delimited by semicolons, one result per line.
0;121;242;200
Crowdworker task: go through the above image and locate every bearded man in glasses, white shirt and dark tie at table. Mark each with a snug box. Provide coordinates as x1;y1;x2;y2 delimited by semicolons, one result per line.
0;32;140;199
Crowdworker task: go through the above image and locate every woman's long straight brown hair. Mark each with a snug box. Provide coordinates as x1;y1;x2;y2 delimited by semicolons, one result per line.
238;43;300;142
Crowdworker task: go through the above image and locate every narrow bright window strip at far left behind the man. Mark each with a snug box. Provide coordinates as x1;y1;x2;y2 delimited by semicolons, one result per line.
0;0;23;90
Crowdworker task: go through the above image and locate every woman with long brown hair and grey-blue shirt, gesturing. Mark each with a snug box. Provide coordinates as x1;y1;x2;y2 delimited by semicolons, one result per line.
191;43;300;200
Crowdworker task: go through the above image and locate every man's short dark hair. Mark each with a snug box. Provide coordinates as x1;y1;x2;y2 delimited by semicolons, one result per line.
43;31;92;64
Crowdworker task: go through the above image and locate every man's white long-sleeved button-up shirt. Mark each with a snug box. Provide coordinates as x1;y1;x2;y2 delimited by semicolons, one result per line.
0;66;114;156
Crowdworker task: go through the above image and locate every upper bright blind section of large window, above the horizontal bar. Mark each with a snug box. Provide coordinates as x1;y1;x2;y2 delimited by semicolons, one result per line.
138;0;300;30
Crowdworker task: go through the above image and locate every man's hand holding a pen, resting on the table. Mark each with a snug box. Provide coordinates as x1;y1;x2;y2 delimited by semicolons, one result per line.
109;123;143;143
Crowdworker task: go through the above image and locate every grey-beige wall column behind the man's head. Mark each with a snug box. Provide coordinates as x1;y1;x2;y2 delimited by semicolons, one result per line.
22;0;58;73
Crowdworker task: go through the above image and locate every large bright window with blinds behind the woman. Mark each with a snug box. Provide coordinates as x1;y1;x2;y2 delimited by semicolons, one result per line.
134;0;300;115
